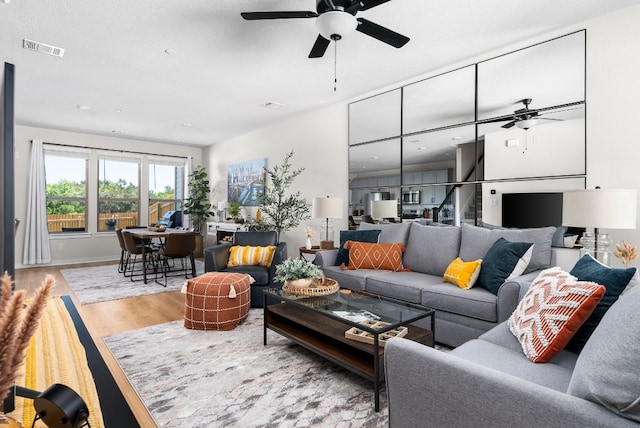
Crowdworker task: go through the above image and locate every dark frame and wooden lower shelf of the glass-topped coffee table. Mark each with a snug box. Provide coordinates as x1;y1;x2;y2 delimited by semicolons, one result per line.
263;290;435;412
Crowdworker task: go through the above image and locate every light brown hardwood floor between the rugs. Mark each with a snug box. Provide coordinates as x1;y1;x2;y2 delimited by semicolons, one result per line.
15;263;184;428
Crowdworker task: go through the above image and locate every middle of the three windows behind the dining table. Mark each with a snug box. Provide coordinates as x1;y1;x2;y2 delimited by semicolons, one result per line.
98;156;140;231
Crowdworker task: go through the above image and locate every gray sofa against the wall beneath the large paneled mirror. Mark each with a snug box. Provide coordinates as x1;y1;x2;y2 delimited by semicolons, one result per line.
316;222;556;346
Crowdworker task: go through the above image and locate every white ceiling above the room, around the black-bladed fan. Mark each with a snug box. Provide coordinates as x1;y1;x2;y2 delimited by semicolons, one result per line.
0;0;640;146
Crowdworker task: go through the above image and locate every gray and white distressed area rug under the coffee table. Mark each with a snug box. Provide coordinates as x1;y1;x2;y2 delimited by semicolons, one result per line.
104;309;388;428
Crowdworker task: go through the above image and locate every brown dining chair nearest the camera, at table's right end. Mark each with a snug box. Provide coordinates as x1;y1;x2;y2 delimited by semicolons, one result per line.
156;232;196;287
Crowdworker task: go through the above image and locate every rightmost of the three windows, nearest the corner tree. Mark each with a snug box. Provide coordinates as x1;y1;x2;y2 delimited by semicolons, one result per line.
148;159;185;227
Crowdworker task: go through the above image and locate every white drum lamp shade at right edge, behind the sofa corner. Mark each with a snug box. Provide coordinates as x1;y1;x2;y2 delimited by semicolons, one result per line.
562;189;637;229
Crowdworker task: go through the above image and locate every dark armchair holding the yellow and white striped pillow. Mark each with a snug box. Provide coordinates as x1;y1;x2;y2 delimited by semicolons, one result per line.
204;231;287;308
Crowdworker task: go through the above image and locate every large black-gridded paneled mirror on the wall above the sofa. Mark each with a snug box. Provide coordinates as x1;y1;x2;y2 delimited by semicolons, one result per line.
349;31;586;231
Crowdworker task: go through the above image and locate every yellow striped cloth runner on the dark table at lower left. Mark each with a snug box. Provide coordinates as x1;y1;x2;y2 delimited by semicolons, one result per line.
10;297;104;428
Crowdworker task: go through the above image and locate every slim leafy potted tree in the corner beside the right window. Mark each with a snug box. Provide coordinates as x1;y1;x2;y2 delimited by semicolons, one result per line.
184;165;214;257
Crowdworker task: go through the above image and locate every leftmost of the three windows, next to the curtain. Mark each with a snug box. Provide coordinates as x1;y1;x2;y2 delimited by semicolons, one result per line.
44;150;88;233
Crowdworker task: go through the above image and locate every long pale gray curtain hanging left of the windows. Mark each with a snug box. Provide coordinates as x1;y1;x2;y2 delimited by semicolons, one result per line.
22;140;51;265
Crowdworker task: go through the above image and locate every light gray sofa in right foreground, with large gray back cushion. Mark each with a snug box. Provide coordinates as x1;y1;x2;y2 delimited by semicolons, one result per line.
384;280;640;428
